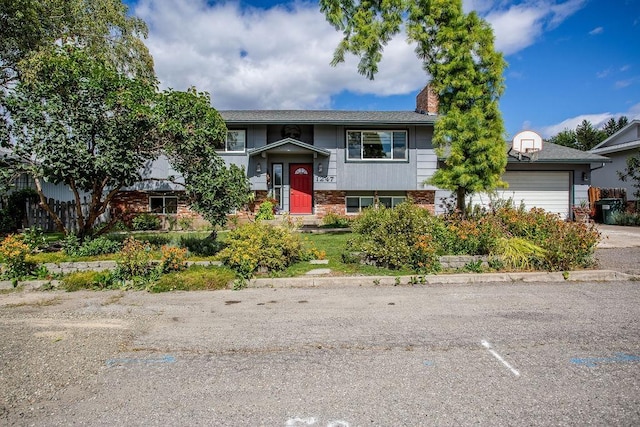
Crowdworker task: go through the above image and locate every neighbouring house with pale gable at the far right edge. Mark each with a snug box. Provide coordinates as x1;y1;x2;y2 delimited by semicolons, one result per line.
590;119;640;201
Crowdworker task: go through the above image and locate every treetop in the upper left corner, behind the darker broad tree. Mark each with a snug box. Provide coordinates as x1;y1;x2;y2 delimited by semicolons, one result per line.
0;0;154;88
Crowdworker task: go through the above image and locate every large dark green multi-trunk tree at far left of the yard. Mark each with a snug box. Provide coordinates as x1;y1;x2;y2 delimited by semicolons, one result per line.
3;46;157;238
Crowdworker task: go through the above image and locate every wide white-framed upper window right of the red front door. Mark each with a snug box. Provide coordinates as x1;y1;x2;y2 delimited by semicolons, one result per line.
347;130;407;160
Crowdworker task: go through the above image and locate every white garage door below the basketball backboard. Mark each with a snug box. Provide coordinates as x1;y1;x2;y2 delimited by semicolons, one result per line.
473;171;571;219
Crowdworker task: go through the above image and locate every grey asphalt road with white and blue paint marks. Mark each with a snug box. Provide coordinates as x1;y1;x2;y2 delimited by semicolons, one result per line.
0;281;640;427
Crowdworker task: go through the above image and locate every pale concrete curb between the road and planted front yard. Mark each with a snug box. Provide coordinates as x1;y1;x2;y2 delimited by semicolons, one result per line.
0;270;640;291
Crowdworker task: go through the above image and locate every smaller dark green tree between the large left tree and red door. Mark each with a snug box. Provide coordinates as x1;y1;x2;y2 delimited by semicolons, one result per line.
156;88;249;239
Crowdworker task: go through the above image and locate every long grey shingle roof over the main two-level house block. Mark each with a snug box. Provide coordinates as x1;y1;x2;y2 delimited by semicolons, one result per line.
220;110;437;125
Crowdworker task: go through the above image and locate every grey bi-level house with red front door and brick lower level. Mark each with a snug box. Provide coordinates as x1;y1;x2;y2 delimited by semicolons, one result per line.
114;86;608;226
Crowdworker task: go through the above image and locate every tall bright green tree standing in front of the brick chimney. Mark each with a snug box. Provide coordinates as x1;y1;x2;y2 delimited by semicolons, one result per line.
320;0;507;212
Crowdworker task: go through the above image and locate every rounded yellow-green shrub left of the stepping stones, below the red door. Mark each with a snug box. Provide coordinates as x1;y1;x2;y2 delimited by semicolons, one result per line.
217;221;310;278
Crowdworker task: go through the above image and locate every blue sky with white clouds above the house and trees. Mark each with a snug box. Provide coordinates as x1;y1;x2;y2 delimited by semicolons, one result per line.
127;0;640;137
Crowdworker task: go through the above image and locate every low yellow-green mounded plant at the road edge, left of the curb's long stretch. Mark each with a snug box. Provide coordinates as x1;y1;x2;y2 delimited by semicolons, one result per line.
147;265;236;292
